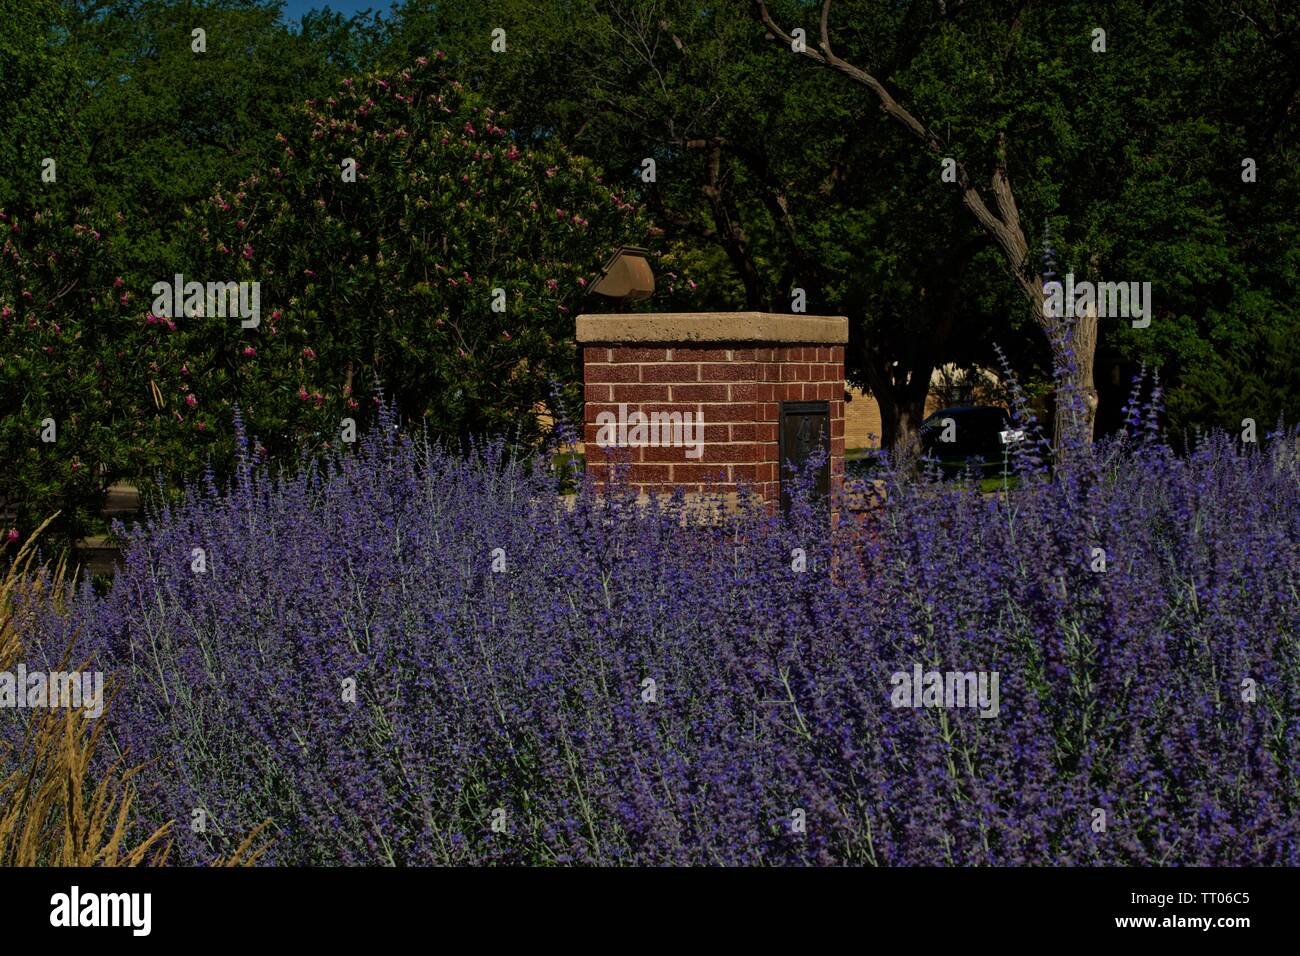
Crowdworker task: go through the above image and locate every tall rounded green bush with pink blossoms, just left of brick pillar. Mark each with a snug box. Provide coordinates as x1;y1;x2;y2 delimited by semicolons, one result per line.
186;61;650;455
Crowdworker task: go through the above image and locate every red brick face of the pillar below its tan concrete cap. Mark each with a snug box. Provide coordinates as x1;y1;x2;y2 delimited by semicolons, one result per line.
582;343;844;501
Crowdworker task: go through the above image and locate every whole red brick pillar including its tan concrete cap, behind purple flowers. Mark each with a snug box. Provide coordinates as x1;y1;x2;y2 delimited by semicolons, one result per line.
577;312;849;502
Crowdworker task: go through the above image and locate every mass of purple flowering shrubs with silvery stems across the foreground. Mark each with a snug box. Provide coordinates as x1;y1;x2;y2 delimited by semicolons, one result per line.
12;405;1300;865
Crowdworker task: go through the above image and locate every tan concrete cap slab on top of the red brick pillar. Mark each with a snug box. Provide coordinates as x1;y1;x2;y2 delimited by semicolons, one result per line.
577;312;849;345
